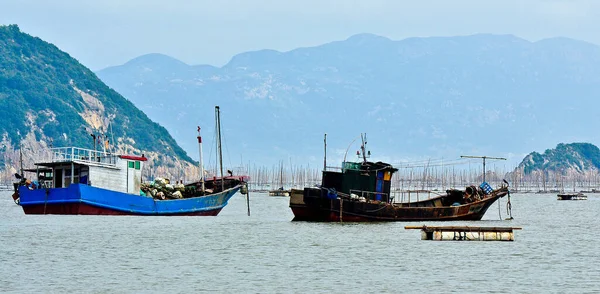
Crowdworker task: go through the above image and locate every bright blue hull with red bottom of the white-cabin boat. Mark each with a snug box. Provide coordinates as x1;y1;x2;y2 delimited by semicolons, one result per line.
19;184;241;215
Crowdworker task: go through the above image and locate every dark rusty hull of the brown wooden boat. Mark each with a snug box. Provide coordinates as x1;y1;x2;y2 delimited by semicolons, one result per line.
290;189;506;222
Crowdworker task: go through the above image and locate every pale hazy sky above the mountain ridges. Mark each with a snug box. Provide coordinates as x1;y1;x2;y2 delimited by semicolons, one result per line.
0;0;600;70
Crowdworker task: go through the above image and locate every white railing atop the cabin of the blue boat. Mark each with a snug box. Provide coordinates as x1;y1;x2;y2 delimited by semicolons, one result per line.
50;147;118;167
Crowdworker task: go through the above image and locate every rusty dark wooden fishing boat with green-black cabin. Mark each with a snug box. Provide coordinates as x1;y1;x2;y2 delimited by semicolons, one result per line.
290;134;510;222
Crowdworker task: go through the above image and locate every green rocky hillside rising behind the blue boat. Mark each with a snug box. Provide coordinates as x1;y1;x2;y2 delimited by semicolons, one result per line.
0;25;191;172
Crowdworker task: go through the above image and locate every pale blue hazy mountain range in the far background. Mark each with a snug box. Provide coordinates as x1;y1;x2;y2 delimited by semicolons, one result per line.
97;34;600;164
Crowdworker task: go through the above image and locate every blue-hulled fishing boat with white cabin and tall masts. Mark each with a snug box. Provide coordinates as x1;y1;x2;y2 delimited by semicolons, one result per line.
13;106;247;215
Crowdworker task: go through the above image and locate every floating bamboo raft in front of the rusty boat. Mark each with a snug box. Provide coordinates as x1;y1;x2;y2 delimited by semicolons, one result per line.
404;226;521;241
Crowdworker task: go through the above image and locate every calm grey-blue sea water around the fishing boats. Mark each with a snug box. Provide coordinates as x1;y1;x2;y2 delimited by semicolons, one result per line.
0;192;600;293
